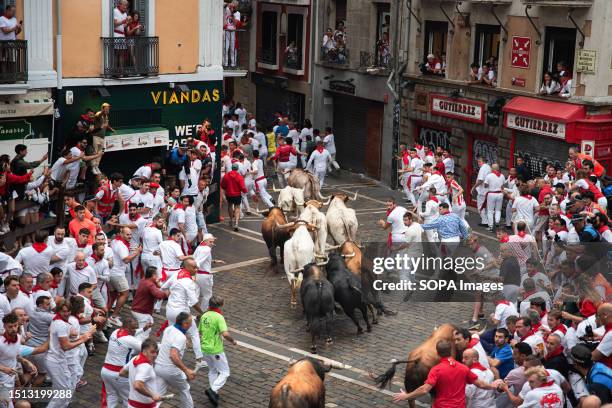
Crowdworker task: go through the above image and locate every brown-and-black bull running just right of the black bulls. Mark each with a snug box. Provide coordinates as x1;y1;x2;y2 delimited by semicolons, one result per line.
340;241;396;324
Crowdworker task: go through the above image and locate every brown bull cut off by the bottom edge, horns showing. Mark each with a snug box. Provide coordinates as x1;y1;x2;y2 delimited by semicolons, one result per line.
268;357;343;408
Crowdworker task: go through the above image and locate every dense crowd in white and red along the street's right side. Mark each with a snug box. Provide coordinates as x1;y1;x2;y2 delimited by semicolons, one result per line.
390;144;612;408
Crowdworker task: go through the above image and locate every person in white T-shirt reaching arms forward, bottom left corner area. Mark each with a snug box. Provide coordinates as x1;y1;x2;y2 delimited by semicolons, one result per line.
47;300;95;408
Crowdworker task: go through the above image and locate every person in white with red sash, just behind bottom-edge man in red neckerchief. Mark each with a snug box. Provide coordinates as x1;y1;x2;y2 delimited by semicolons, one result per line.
100;316;149;407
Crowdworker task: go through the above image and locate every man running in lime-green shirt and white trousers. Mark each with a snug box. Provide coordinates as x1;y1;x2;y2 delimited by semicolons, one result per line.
198;296;238;407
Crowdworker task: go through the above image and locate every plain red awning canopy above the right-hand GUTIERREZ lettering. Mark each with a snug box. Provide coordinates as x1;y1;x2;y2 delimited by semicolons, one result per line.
503;96;586;123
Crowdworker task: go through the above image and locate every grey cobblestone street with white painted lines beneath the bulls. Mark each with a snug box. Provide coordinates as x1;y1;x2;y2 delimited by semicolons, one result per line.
71;171;498;408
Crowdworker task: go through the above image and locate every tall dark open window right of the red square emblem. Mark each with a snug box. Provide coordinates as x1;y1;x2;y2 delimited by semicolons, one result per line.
544;27;576;76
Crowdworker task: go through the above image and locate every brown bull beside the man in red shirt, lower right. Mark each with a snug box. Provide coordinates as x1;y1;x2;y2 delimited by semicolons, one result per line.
374;324;457;408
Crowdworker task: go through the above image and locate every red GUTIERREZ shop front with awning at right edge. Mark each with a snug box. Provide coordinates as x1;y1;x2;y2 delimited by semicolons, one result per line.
503;97;612;177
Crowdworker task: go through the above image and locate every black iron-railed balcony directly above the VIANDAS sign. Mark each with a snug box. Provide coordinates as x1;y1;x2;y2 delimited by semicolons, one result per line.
102;36;159;78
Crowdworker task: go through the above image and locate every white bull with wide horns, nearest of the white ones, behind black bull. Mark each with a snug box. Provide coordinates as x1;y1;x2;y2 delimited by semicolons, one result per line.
276;220;326;307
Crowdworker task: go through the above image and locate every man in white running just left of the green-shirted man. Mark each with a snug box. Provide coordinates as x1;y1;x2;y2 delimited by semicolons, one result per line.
161;257;204;361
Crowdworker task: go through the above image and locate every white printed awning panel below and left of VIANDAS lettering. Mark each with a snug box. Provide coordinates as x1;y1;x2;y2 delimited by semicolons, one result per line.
104;127;170;152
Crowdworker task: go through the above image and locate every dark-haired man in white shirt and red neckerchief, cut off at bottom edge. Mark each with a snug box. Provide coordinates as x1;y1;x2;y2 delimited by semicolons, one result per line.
119;339;161;408
